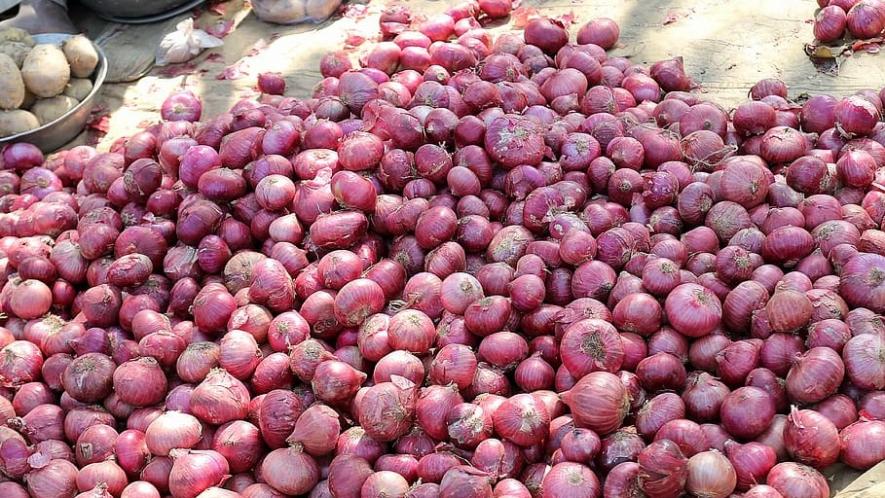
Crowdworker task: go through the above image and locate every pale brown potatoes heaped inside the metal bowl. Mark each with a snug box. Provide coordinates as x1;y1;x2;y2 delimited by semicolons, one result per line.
0;28;98;137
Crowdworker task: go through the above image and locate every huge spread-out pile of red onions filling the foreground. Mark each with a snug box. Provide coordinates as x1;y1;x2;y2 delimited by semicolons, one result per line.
0;0;885;498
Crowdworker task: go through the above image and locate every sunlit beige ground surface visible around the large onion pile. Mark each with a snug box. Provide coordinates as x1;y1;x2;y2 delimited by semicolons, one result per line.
62;0;885;498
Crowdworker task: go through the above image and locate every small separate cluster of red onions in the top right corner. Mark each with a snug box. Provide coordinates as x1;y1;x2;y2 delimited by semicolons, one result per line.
813;0;885;43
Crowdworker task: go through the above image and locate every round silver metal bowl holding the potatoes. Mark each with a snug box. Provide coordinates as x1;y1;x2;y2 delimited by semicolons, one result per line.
0;33;108;152
